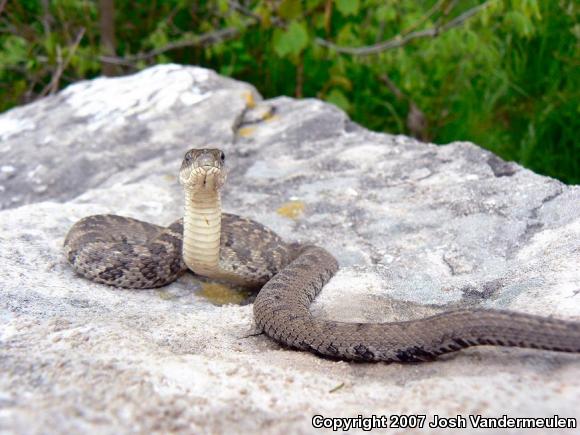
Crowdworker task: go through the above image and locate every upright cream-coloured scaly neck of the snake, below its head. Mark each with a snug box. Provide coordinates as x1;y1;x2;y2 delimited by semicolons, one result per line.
183;189;222;276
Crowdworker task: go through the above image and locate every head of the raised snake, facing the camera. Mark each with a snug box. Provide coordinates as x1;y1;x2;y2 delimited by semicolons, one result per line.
179;148;226;191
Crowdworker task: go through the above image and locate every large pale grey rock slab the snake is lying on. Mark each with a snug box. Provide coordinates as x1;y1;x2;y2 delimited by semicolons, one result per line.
0;65;580;434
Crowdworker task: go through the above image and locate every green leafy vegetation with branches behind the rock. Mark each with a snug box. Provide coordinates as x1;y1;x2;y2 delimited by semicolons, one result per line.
0;0;580;183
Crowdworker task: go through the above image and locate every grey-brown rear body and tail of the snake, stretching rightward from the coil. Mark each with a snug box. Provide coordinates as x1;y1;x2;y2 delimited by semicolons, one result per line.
254;246;580;362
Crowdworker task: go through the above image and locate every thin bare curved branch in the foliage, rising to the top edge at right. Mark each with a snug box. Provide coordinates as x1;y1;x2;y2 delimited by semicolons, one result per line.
315;1;489;56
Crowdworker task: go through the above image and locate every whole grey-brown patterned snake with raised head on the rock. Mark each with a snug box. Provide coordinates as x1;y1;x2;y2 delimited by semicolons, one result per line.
64;148;580;363
